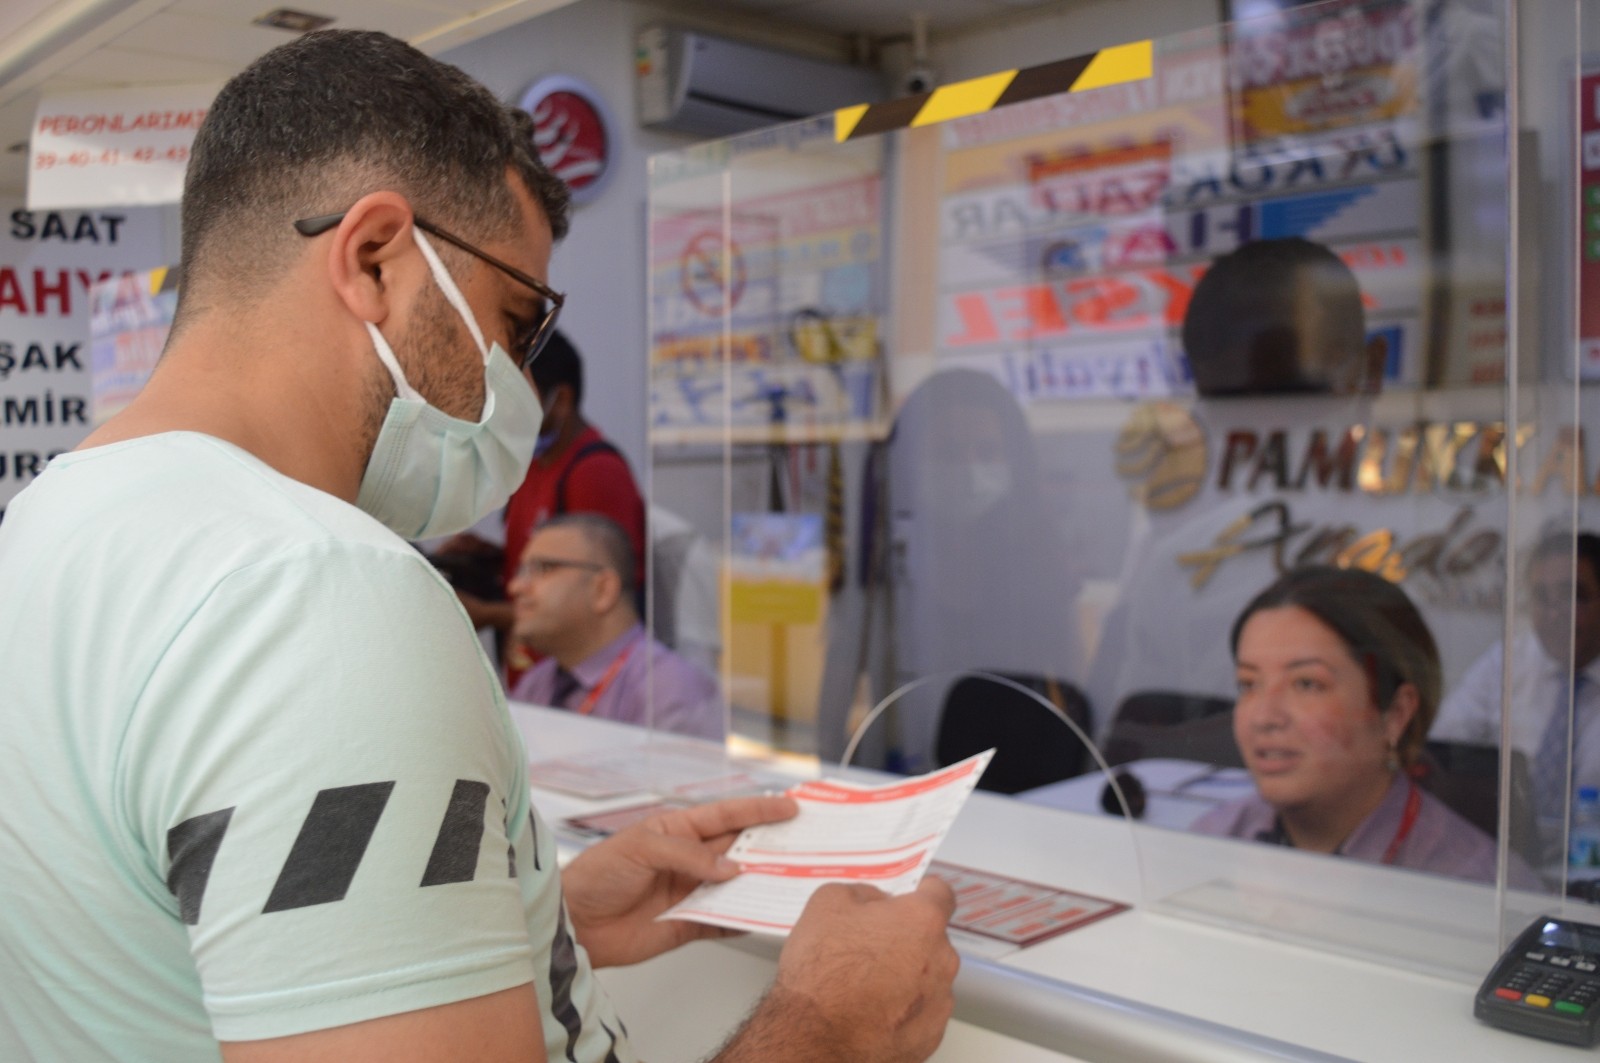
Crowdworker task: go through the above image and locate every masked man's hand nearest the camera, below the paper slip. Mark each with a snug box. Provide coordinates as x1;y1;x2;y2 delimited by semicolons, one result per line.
717;877;960;1063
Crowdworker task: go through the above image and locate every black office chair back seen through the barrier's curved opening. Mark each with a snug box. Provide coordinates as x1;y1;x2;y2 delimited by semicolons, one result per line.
934;672;1090;794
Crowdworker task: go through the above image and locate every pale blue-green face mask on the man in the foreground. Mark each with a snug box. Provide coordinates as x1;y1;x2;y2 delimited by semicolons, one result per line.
355;231;542;540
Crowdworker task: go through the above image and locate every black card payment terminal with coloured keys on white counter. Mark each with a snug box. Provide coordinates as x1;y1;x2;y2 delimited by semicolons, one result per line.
1472;916;1600;1045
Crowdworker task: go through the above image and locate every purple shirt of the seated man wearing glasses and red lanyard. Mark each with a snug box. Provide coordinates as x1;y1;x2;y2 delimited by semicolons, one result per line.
510;624;723;741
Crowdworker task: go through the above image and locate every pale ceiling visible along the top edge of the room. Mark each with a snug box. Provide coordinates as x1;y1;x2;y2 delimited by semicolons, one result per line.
0;0;1066;195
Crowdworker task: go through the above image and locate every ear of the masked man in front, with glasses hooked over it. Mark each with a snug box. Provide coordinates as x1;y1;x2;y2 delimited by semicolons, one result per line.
316;192;424;325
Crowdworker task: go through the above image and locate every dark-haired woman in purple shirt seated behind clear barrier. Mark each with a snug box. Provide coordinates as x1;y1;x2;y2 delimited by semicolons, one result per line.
1194;567;1538;887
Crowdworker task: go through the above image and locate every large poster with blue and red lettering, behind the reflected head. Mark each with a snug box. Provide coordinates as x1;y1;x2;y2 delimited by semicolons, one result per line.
936;3;1426;402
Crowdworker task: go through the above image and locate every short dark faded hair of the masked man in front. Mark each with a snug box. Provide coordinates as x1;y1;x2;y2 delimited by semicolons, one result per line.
174;30;568;323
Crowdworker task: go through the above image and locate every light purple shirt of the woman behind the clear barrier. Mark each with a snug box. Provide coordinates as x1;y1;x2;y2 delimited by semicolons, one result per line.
1190;772;1544;890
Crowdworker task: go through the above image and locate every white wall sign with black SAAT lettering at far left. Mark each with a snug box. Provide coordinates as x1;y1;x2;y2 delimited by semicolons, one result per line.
0;200;162;509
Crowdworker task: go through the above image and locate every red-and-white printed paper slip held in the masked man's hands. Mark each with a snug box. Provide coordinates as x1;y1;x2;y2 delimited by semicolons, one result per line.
661;749;994;937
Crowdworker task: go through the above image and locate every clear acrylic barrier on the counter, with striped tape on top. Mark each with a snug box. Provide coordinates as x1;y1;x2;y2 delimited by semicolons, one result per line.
648;0;1600;977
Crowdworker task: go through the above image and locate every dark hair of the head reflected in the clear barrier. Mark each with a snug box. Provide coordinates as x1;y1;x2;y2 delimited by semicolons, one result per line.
1184;237;1376;395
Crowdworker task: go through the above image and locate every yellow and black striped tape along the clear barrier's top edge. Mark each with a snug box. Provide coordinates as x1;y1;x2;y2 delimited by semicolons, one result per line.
834;40;1155;141
